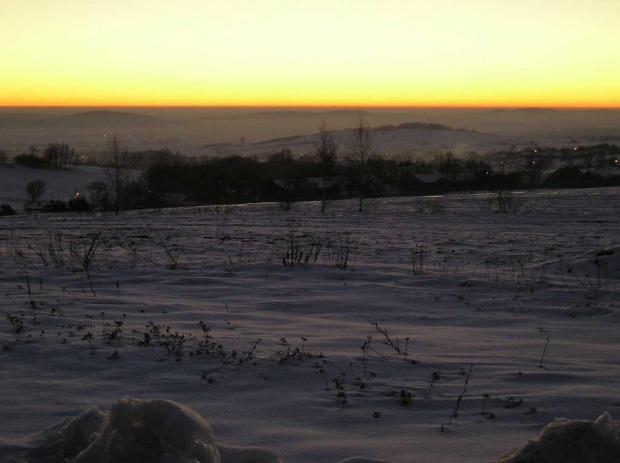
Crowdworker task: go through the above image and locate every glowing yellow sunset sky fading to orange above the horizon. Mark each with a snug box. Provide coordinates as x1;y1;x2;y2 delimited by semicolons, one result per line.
0;0;620;108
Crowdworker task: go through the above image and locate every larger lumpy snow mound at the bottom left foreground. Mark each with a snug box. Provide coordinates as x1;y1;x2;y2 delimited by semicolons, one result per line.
7;398;284;463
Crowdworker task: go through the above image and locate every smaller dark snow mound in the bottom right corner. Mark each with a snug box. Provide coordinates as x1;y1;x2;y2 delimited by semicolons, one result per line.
500;413;620;463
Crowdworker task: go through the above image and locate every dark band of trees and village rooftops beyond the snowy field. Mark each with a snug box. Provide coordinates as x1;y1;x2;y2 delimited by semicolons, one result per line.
0;143;620;213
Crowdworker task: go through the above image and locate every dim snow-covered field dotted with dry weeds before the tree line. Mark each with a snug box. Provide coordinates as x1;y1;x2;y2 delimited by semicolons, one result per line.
0;188;620;463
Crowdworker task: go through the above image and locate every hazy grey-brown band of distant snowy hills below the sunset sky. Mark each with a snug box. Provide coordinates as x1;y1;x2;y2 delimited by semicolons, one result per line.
0;107;620;156
